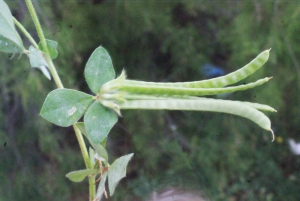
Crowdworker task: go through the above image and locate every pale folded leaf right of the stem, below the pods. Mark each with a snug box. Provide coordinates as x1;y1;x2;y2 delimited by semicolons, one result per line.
108;153;133;196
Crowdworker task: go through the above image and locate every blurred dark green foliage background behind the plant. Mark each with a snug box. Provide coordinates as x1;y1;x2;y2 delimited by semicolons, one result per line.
0;0;300;201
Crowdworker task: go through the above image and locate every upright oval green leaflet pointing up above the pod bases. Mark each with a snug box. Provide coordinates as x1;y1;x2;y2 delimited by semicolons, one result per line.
84;46;116;94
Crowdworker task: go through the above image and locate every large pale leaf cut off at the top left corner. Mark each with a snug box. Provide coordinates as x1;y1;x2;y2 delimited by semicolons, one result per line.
0;0;25;53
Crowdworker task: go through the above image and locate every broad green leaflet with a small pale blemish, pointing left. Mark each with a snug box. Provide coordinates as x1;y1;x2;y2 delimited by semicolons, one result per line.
40;89;94;127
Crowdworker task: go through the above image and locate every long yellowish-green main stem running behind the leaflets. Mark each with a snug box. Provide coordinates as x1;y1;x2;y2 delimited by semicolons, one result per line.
26;0;95;201
